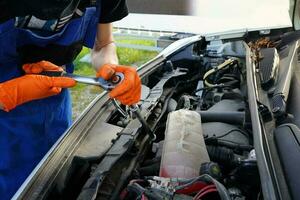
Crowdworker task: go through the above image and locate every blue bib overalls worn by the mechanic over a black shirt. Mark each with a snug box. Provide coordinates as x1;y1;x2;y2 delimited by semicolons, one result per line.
0;7;99;200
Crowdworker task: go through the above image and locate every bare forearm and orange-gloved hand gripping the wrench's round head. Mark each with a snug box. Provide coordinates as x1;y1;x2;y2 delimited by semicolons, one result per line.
92;23;141;105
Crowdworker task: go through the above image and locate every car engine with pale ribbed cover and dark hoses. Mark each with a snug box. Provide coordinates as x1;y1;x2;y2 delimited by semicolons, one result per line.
84;41;260;200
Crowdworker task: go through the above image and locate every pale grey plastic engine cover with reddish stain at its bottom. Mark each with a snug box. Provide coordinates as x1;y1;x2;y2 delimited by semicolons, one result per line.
160;110;210;178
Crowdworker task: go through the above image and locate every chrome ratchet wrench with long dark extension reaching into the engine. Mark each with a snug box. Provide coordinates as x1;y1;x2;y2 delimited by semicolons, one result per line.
40;71;156;141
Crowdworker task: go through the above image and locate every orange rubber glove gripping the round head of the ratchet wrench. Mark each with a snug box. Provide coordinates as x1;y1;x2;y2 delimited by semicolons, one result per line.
96;64;142;105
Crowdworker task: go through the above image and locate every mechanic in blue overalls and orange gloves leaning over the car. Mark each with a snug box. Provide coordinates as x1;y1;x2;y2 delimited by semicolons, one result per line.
0;0;141;199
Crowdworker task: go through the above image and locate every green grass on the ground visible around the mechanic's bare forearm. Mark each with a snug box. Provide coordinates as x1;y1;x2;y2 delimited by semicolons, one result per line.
71;37;157;119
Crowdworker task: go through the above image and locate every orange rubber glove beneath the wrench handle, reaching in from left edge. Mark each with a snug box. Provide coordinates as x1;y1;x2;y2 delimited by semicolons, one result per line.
0;75;76;112
